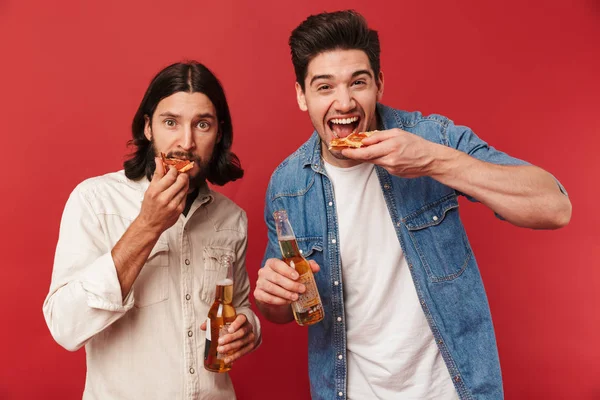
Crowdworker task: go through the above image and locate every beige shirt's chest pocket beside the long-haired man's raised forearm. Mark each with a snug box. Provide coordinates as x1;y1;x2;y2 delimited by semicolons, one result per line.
133;240;169;308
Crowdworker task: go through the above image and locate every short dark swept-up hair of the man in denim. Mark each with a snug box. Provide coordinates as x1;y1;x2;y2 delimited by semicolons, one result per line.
289;10;381;90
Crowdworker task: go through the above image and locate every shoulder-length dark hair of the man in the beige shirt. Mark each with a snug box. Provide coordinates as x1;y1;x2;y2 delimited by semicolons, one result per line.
123;61;244;185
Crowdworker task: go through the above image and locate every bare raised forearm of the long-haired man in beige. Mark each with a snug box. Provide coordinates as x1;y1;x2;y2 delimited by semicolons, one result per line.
111;219;160;298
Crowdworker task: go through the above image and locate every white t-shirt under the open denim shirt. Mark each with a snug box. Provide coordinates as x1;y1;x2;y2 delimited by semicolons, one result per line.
325;163;458;400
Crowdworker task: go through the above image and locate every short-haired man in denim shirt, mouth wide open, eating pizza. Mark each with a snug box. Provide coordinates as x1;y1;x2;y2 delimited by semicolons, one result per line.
254;11;571;400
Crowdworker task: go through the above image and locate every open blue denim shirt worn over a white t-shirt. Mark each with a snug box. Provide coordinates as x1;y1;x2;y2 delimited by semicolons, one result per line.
262;104;552;400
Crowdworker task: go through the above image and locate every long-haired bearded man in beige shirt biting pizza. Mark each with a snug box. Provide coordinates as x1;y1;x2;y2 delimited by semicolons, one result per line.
43;62;261;399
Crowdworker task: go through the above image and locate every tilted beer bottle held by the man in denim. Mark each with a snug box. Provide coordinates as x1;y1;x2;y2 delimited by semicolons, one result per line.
273;210;325;325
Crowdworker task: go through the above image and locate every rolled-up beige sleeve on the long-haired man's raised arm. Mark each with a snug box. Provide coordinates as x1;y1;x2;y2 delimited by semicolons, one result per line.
43;187;134;351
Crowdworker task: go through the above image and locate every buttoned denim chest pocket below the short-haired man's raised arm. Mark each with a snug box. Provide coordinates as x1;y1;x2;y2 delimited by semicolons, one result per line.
403;195;472;282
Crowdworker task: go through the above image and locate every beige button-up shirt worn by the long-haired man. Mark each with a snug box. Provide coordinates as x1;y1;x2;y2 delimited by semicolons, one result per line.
43;171;261;400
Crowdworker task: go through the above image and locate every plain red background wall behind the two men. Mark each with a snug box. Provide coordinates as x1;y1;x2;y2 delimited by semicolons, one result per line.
0;0;600;400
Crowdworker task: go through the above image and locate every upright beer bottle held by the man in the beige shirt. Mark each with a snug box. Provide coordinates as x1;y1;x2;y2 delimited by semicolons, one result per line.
204;256;236;372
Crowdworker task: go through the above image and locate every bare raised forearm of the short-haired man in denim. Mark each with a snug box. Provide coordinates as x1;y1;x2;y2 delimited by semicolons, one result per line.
428;145;571;229
